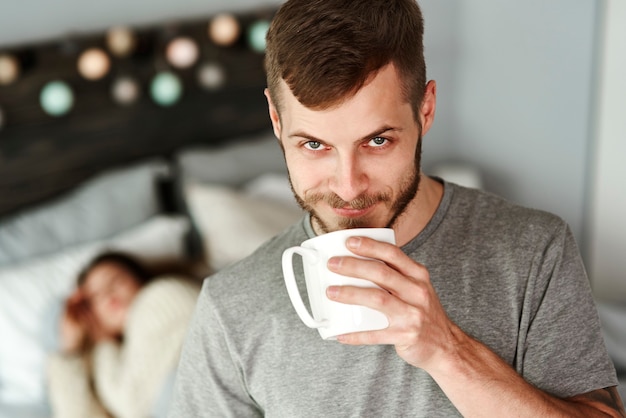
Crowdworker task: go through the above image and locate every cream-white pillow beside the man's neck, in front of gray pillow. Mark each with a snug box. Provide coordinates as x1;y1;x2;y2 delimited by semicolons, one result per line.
184;182;303;271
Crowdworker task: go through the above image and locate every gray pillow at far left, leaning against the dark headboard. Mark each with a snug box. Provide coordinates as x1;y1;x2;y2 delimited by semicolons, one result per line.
0;160;170;266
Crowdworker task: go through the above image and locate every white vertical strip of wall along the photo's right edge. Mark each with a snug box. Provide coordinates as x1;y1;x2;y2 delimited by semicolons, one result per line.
588;0;626;302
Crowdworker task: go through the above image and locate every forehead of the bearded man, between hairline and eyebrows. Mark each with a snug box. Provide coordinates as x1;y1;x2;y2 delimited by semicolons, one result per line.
280;64;416;139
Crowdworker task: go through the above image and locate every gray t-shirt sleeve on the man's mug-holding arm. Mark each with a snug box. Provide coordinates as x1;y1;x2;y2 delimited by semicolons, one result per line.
518;221;617;397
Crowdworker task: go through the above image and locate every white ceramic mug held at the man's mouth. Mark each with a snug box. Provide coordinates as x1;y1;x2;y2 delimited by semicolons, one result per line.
282;228;395;340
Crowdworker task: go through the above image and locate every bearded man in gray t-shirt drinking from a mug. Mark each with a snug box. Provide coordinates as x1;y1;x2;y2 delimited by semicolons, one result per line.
171;0;624;417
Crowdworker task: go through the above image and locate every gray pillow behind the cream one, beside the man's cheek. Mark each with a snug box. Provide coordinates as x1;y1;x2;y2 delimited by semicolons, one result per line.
176;131;287;187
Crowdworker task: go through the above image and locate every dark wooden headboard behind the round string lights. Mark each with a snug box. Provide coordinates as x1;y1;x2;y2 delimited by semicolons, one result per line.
0;10;273;218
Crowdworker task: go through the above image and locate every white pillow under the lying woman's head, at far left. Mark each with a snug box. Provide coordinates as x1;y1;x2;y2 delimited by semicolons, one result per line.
0;215;190;405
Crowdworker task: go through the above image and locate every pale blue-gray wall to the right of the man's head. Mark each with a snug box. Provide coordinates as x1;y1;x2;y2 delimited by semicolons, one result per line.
421;0;596;251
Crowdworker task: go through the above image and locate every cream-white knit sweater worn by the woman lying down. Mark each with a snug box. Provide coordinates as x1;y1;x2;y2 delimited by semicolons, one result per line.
48;277;200;418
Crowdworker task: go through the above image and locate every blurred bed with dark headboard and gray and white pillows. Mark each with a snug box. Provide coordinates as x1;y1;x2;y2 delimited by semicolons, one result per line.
0;5;302;418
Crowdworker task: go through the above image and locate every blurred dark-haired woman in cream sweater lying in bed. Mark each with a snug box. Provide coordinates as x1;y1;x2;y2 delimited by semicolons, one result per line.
48;252;199;418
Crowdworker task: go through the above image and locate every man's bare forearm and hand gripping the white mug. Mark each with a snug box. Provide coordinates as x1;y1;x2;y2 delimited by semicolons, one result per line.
327;238;624;417
